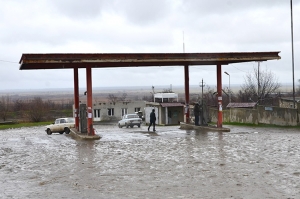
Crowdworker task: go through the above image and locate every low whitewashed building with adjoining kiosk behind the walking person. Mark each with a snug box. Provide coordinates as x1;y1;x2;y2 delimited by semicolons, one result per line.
77;93;184;125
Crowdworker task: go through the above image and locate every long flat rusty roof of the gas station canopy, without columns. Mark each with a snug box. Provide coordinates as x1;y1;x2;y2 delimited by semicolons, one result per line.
19;51;280;70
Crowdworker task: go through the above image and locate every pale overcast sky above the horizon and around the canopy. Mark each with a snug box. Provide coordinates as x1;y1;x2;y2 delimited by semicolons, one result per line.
0;0;300;90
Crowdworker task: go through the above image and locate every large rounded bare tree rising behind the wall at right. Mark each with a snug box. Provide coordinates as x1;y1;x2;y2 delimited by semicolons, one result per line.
239;68;281;101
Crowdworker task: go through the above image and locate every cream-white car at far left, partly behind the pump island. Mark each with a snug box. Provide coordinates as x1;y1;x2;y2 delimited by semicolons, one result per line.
46;118;75;135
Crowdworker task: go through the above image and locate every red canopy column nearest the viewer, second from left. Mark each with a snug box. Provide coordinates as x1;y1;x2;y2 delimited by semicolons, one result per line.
86;67;95;135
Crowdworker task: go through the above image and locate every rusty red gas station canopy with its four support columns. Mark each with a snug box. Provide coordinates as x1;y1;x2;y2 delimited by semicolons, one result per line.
20;51;280;132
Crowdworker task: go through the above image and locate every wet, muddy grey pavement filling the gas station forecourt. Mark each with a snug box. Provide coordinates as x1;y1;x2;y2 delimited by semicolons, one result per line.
0;125;300;199
